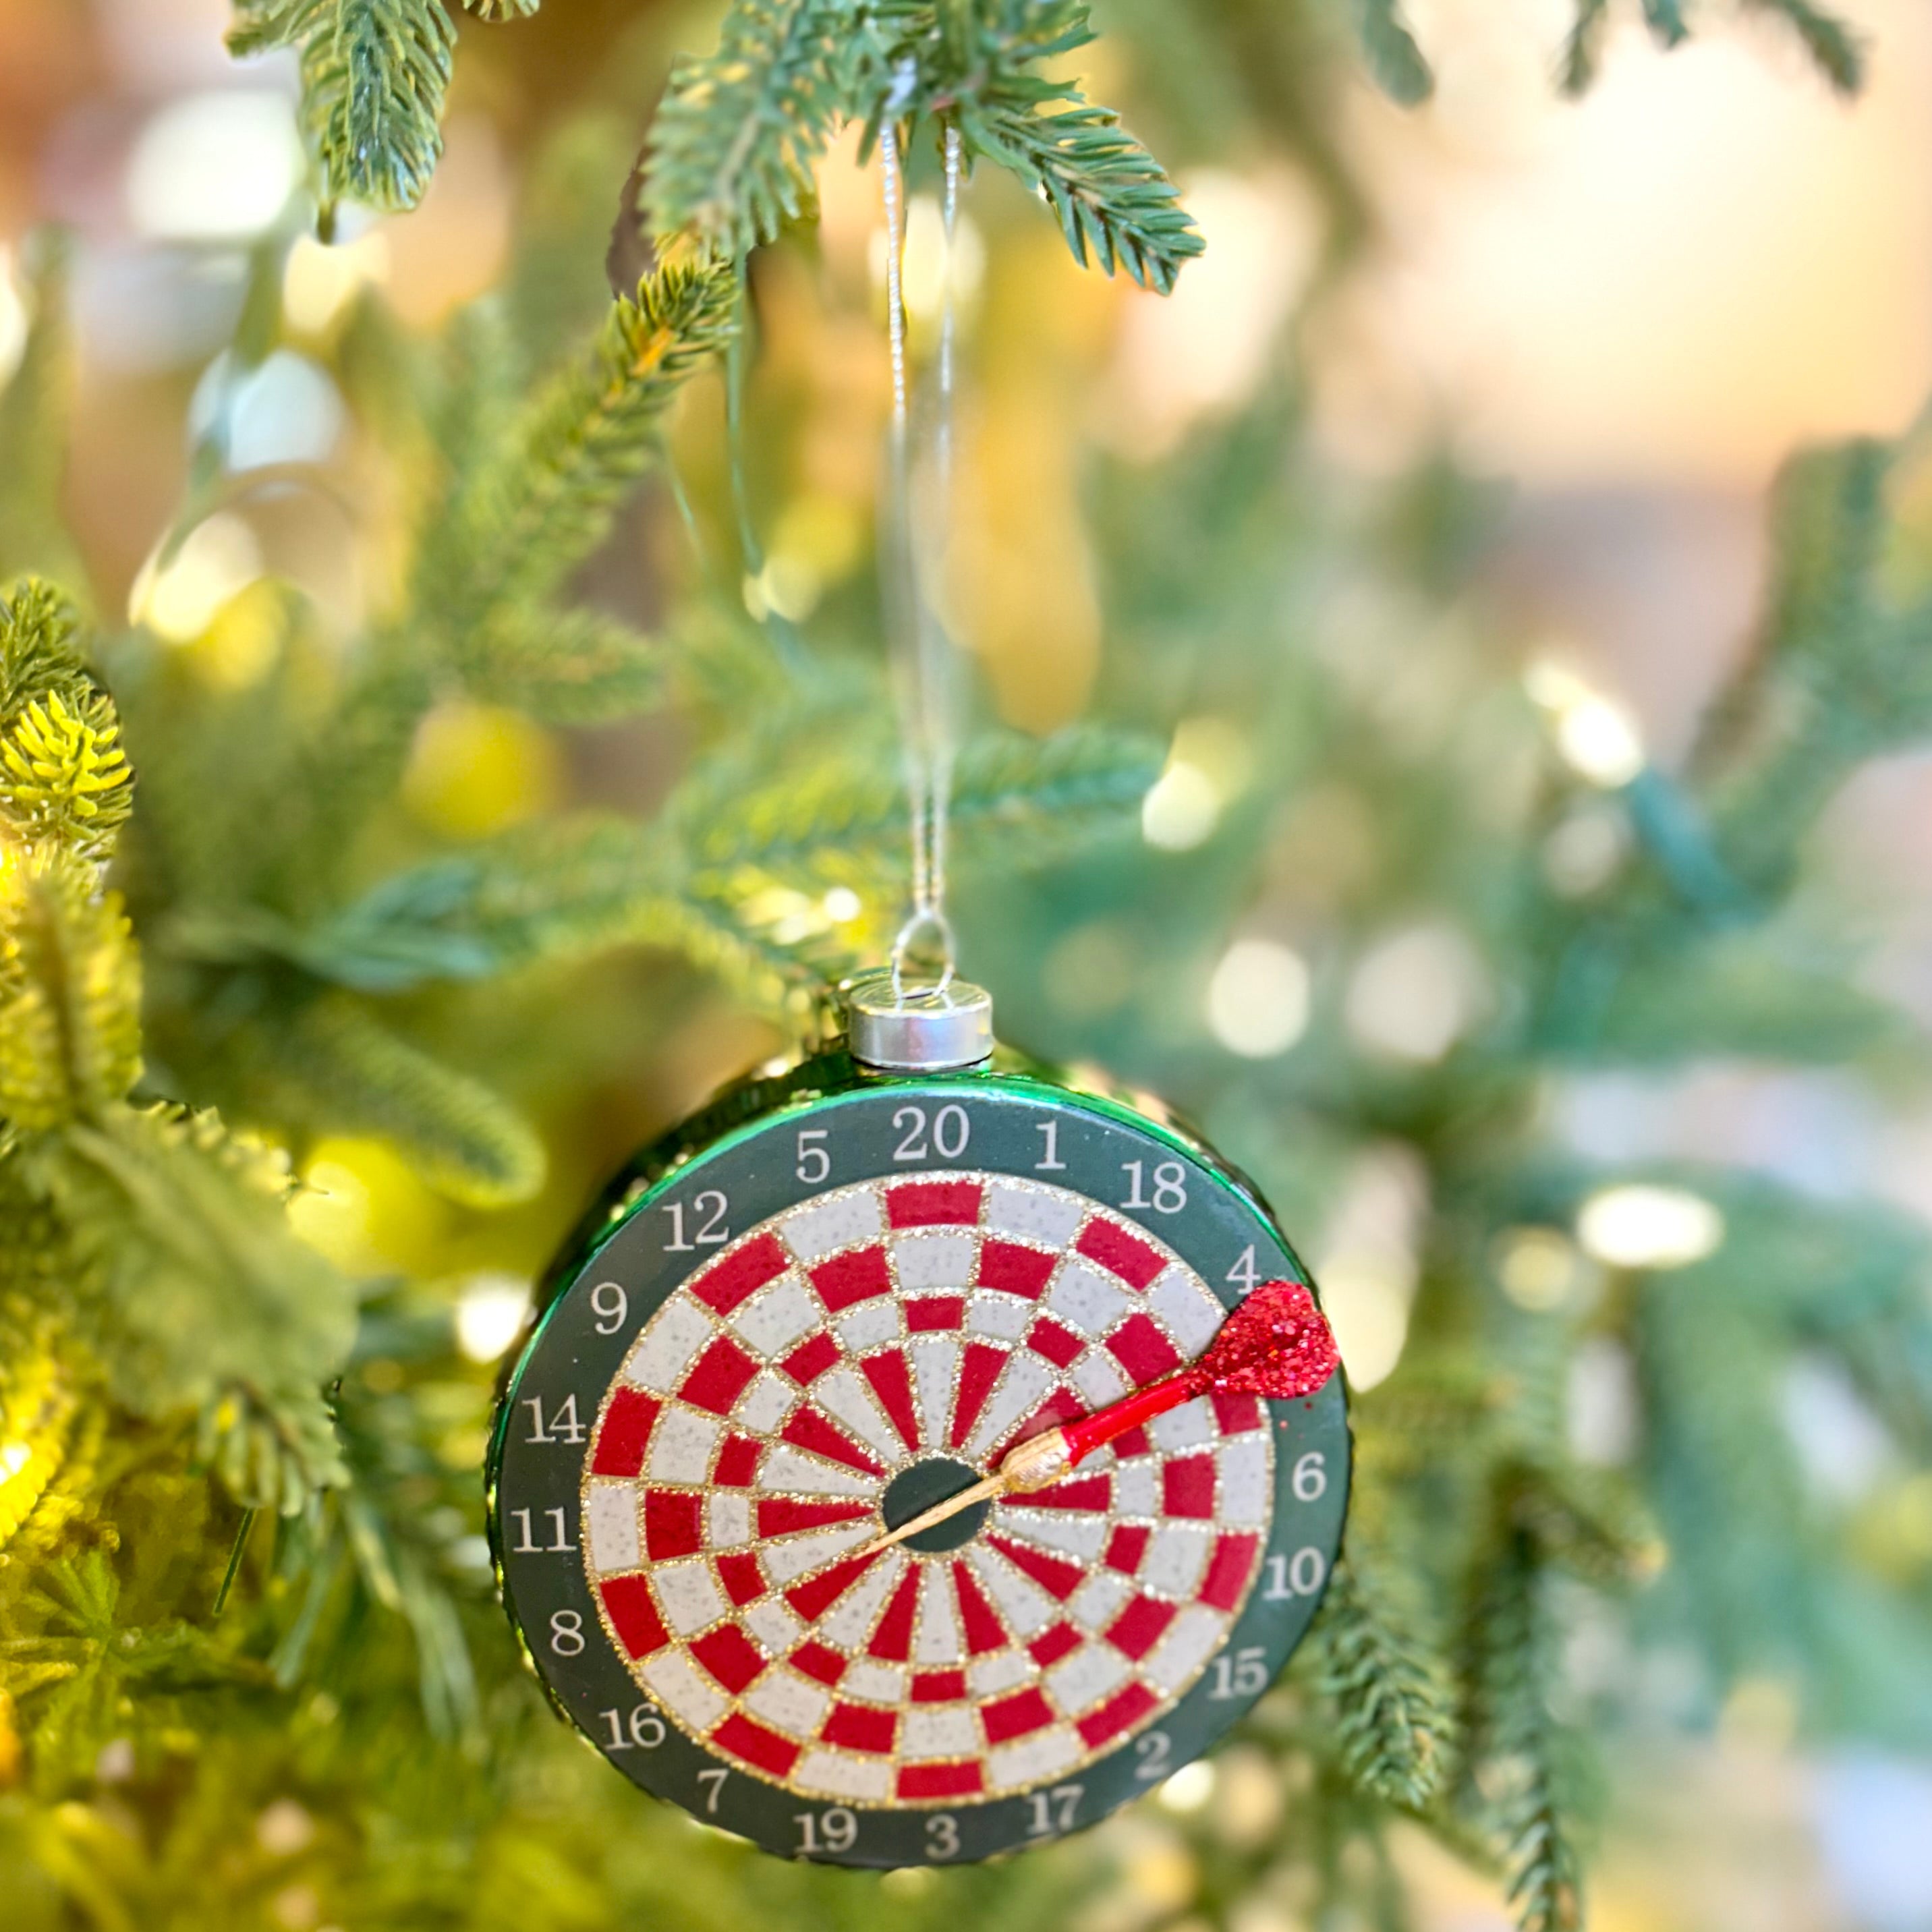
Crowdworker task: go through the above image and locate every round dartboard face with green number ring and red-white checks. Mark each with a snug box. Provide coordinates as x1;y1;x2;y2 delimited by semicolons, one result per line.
492;1074;1348;1867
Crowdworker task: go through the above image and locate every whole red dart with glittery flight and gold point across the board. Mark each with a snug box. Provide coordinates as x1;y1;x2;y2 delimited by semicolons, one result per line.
845;1281;1341;1563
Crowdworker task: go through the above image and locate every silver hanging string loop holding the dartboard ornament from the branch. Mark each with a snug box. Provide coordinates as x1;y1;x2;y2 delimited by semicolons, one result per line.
879;92;960;1001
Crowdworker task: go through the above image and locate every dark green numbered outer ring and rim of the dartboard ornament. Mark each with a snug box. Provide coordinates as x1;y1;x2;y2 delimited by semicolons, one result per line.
485;1051;1351;1867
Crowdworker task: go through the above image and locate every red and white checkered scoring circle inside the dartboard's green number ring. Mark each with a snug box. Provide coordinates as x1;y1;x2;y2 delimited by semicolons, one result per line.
584;1172;1275;1805
